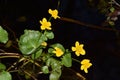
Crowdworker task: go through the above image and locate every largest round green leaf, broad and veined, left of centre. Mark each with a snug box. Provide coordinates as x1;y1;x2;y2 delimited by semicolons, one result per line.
18;30;47;55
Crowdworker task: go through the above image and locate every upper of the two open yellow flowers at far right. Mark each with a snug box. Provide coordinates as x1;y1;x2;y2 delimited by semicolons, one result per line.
72;41;85;56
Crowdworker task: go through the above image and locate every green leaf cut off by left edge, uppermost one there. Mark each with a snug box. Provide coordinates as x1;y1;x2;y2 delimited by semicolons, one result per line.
0;26;8;43
